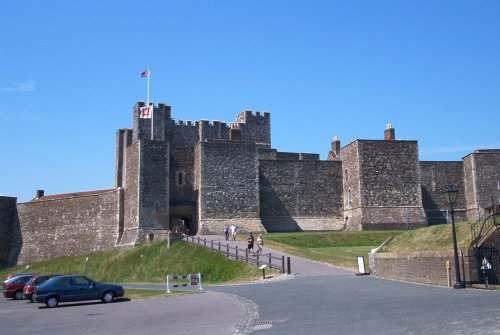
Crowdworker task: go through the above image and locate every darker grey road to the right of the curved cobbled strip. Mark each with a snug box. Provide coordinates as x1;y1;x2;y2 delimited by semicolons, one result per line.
207;276;500;335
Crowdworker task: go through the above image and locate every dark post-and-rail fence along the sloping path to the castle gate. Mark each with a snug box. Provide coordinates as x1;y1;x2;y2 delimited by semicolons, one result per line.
182;235;292;274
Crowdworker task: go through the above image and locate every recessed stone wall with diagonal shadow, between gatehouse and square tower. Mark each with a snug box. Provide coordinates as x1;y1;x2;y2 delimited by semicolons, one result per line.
259;160;344;232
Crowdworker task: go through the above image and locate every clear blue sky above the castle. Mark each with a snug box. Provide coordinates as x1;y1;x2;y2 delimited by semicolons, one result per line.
0;0;500;202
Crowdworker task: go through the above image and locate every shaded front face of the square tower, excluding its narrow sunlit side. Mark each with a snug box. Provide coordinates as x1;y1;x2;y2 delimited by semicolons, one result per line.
358;141;426;230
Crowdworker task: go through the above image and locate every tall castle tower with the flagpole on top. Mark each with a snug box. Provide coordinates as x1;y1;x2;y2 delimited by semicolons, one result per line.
115;102;170;246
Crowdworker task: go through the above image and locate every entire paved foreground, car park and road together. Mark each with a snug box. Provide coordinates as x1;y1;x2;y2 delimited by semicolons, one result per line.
0;237;500;335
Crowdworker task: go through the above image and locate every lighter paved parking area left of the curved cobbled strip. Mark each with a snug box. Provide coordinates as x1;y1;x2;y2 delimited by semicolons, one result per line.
0;292;245;335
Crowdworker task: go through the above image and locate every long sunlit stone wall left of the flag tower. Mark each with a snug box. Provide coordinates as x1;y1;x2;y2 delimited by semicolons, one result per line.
17;190;121;264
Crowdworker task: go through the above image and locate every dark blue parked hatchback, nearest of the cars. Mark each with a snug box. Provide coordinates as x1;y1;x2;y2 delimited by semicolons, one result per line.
33;275;125;307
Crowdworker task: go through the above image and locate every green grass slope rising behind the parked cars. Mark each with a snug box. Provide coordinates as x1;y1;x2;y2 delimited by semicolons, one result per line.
0;242;261;284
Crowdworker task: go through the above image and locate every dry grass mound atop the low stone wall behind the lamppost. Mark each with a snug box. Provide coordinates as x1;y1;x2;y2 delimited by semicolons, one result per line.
380;222;472;252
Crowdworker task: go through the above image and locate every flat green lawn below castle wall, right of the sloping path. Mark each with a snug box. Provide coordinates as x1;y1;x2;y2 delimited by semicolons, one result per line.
264;231;403;269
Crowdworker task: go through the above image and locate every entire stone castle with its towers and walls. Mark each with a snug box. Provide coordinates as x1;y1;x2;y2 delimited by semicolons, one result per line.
0;102;500;266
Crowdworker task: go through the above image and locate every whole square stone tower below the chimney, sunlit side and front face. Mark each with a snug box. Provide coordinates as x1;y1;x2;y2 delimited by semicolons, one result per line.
341;140;426;230
